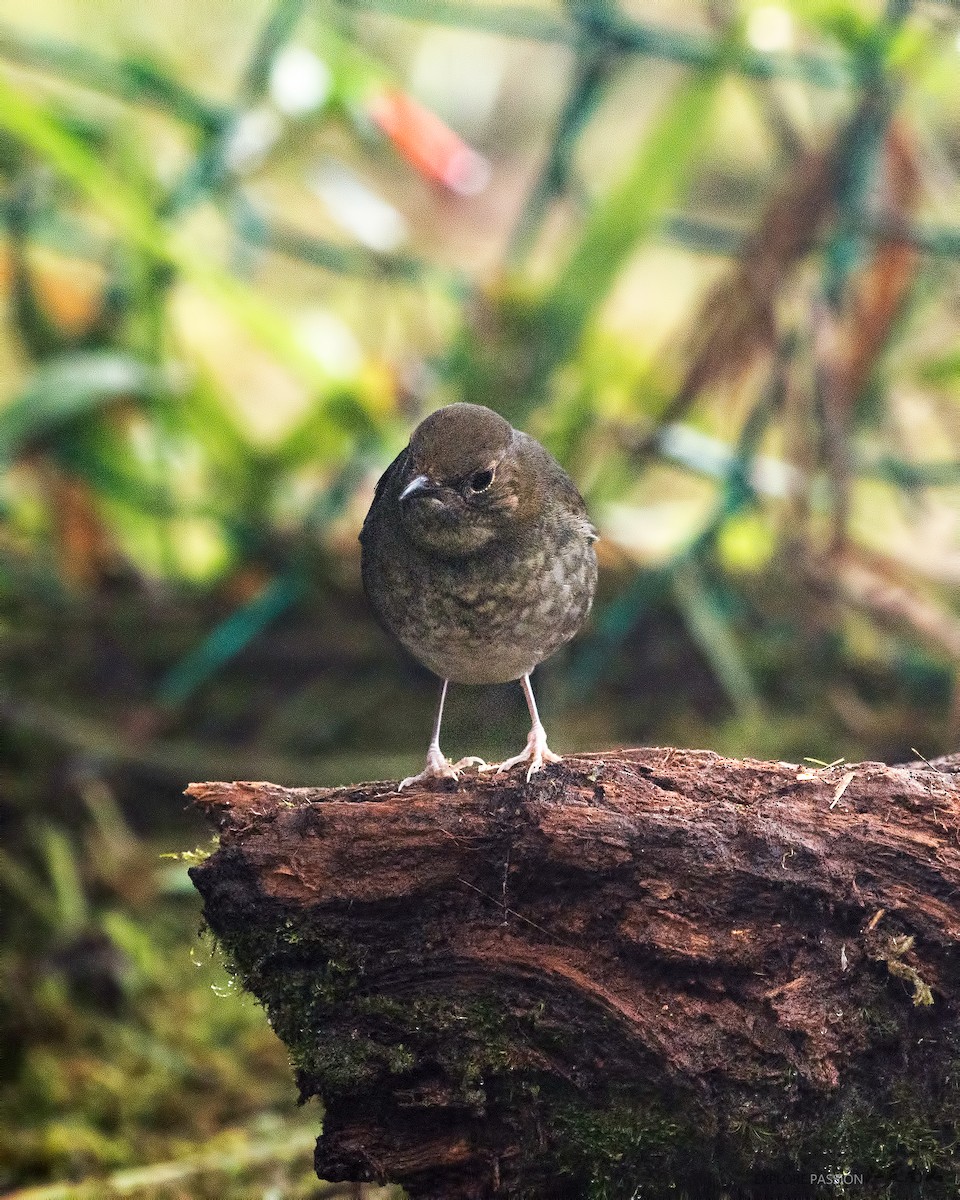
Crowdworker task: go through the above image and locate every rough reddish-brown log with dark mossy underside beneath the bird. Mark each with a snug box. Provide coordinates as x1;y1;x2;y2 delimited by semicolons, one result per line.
190;749;960;1200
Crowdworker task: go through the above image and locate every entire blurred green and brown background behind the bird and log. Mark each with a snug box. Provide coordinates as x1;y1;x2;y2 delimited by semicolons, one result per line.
0;0;960;1200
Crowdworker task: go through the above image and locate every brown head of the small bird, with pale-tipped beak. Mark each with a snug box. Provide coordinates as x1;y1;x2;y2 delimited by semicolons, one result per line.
398;404;535;558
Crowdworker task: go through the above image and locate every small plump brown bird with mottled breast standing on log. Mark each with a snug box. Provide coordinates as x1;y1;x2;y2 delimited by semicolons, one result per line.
360;402;598;791
